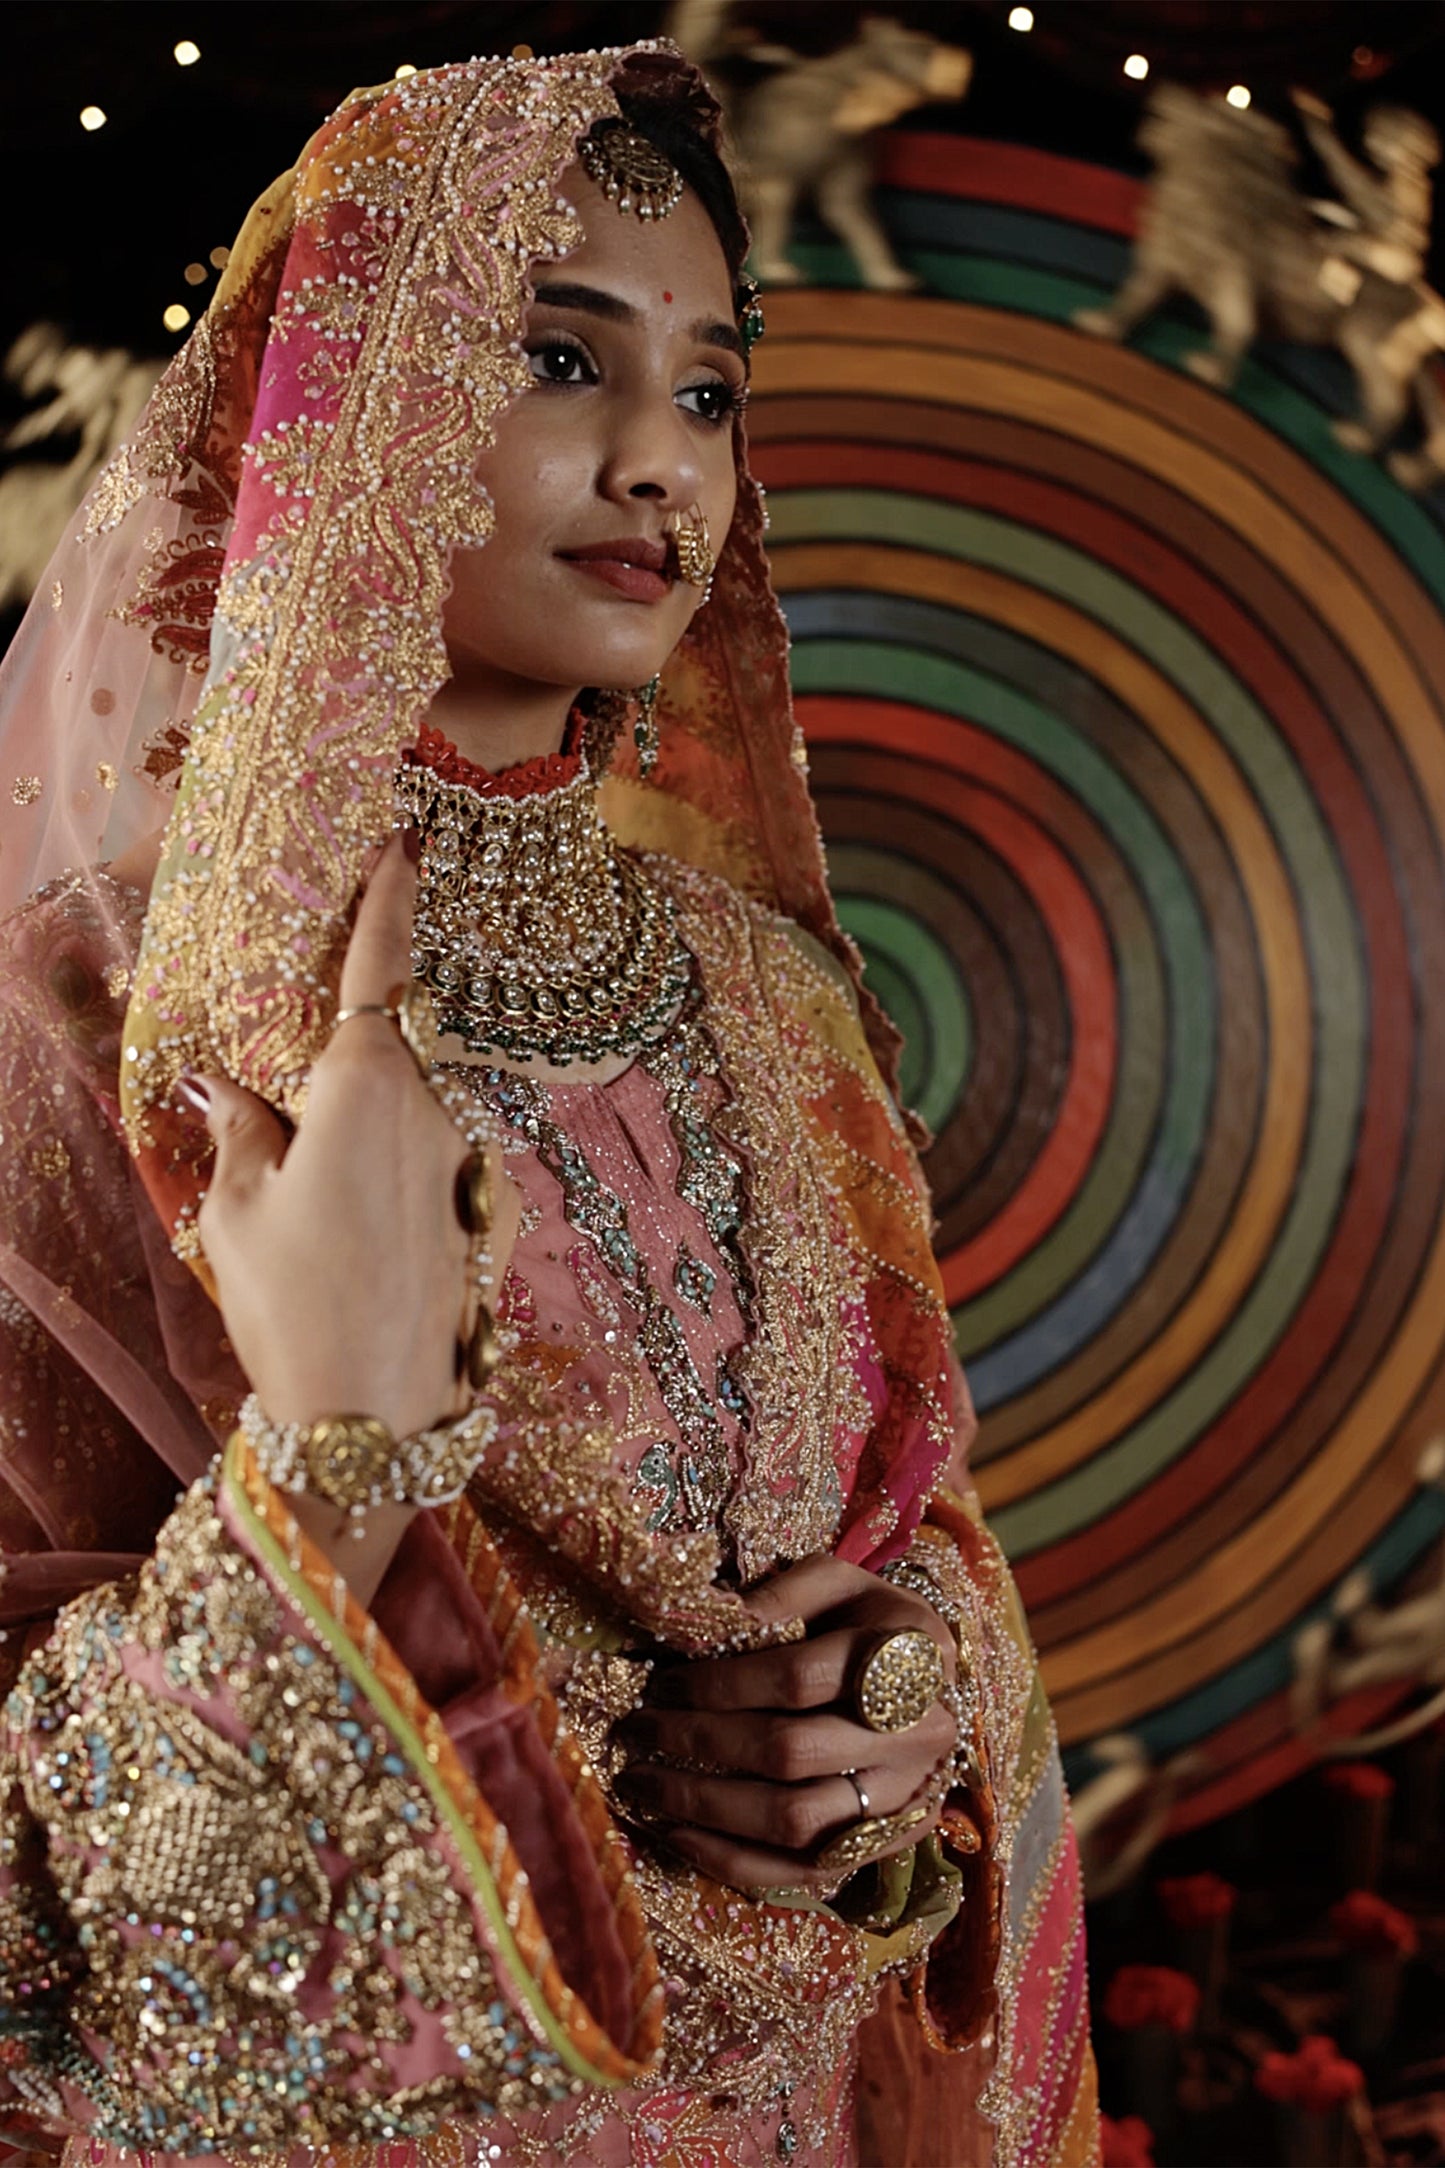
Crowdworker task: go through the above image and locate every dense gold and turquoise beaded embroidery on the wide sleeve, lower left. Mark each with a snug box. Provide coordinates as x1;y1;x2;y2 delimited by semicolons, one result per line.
0;1476;576;2153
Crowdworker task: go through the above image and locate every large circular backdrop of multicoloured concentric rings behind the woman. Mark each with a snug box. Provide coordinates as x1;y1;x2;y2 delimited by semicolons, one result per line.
750;134;1445;1823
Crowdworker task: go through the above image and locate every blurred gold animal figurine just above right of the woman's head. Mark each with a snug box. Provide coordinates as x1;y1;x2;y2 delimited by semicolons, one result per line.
667;0;973;293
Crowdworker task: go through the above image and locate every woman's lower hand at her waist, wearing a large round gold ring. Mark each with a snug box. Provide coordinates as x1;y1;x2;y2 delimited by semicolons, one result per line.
617;1559;958;1890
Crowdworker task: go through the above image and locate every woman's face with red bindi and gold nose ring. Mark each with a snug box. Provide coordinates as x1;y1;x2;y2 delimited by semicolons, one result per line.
442;167;747;692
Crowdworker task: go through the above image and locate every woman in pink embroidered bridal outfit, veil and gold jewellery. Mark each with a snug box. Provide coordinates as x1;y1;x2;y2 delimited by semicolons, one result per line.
0;48;1096;2168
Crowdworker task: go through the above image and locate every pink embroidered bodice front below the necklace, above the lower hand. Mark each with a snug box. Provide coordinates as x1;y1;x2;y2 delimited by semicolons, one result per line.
454;854;882;1578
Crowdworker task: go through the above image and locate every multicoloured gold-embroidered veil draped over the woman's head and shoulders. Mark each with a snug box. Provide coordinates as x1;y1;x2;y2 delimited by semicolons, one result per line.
0;46;1092;2168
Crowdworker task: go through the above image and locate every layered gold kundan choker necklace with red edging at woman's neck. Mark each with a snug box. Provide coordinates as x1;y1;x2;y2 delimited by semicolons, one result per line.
396;726;691;1069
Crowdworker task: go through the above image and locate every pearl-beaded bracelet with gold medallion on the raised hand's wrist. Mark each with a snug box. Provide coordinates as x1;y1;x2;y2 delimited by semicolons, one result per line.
240;1392;496;1539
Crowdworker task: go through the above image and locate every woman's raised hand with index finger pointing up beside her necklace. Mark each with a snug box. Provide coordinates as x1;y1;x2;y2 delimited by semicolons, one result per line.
179;835;520;1598
